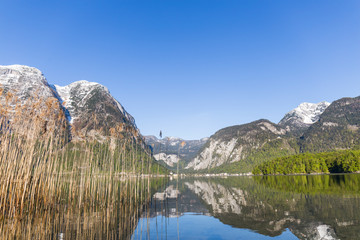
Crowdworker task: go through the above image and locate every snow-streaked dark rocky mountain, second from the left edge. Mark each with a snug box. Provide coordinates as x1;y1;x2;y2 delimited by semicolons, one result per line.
52;80;136;141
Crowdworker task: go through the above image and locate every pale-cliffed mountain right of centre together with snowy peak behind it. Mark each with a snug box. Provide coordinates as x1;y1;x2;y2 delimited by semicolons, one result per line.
185;102;330;172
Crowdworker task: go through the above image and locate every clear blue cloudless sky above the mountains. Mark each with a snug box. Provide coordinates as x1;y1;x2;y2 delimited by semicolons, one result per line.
0;0;360;139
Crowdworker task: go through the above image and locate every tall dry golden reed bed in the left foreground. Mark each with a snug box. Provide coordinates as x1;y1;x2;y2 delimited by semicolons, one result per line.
0;89;167;239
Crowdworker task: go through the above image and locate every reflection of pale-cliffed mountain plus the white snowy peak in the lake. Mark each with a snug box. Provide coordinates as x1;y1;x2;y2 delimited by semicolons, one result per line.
186;179;342;239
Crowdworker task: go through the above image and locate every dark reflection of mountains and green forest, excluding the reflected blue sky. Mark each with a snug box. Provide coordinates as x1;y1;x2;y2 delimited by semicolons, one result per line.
148;175;360;239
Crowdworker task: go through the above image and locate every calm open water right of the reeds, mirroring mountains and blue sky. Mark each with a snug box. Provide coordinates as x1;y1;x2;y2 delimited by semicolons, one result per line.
132;174;360;239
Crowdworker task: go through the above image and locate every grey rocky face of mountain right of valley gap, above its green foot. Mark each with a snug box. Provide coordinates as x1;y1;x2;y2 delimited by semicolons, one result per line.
186;119;293;171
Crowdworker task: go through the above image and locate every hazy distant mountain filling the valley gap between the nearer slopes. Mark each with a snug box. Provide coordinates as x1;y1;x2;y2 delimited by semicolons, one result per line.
145;136;209;170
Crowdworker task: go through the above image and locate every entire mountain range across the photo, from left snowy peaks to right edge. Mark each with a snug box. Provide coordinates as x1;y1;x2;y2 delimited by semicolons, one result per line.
4;65;354;172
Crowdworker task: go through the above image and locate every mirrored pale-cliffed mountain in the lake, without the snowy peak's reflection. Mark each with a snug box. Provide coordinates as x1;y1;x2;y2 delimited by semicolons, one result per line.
186;179;297;236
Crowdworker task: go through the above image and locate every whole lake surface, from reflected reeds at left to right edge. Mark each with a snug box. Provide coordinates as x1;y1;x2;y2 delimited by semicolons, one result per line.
0;174;360;240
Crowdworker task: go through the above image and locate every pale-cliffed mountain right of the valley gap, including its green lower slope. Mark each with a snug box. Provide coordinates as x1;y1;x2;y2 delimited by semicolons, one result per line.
186;119;297;172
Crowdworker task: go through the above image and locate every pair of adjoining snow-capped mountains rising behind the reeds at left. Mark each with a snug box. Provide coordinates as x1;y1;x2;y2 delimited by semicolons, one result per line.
0;65;138;141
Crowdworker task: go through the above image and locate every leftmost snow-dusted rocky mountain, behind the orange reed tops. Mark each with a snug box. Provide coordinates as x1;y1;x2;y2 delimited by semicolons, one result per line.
0;65;69;135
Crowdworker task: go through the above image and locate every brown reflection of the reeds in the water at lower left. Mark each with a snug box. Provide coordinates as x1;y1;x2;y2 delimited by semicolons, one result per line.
0;178;164;239
